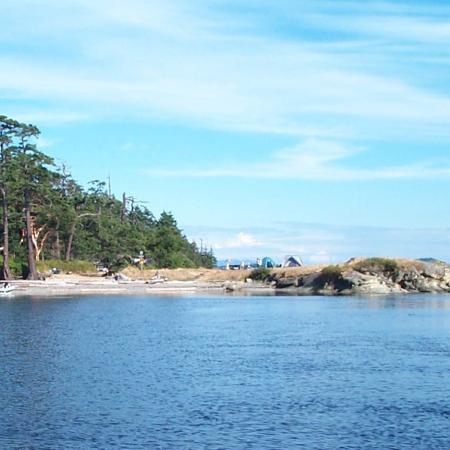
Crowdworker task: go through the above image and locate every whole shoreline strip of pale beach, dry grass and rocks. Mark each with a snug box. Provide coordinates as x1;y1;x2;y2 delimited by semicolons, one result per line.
0;258;450;297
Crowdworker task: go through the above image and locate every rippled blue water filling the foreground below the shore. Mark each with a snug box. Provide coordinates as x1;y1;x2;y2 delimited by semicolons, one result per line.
0;296;450;450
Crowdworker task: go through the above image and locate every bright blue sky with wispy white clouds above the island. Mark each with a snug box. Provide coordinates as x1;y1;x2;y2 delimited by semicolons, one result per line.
0;0;450;262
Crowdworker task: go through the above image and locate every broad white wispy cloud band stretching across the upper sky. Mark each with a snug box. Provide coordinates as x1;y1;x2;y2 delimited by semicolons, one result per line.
0;0;450;138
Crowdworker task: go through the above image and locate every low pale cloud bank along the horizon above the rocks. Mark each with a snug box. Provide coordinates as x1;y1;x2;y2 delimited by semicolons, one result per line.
186;222;450;264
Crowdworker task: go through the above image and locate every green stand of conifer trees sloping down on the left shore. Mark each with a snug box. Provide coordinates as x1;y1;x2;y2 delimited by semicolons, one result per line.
0;116;215;279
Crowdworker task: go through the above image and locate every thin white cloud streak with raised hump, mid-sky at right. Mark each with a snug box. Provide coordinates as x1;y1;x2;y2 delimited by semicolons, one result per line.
146;139;450;181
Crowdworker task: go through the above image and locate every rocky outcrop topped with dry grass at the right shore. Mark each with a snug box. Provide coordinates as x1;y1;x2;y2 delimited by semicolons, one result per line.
268;258;450;295
